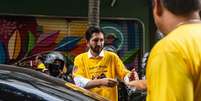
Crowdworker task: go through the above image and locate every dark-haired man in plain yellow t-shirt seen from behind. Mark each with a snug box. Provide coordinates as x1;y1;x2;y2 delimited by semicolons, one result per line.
146;0;201;101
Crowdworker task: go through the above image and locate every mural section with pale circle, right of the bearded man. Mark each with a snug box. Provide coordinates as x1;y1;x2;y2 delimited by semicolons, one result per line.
101;20;143;70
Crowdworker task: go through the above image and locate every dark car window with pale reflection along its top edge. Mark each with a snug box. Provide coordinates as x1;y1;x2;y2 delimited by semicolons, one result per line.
0;80;63;101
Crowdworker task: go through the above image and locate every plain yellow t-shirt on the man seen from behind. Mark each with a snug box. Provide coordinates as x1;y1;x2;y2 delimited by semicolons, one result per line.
146;23;201;101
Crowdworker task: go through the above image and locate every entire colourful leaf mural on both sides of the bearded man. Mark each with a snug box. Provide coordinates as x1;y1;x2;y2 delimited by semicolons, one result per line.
0;16;144;71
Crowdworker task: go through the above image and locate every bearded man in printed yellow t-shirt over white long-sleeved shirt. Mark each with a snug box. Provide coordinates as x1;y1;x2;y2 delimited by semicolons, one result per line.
73;27;137;101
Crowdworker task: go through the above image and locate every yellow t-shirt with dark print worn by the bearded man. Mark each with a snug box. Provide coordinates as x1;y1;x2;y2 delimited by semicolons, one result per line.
73;51;129;101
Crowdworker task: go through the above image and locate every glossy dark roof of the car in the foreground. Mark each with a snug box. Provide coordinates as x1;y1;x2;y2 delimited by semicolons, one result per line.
0;64;108;101
